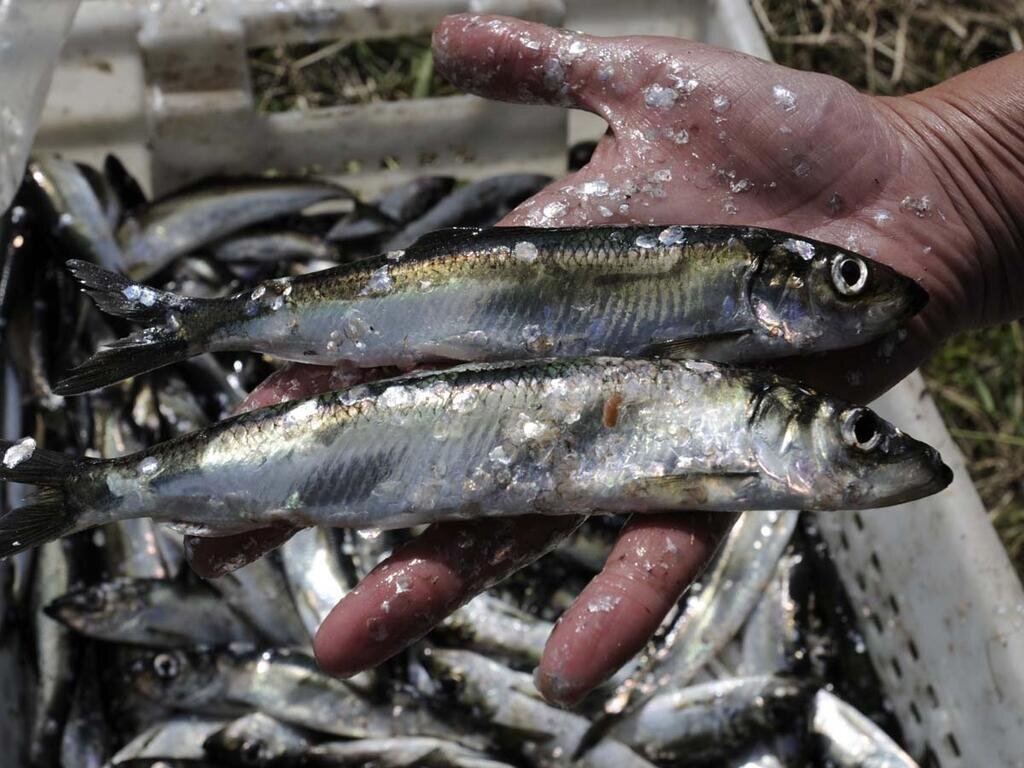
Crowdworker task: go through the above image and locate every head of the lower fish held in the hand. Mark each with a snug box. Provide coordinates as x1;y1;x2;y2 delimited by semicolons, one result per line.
750;385;952;510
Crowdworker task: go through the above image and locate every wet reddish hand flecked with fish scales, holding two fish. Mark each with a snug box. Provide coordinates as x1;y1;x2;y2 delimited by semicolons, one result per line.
190;16;1024;705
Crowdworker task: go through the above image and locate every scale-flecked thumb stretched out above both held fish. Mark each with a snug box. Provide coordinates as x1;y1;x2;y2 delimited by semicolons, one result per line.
433;14;625;122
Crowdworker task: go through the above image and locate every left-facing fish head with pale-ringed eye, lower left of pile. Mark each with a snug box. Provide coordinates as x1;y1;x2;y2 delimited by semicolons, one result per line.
128;650;226;709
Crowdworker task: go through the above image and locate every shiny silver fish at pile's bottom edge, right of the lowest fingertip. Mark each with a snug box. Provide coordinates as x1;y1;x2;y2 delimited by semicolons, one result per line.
610;676;811;761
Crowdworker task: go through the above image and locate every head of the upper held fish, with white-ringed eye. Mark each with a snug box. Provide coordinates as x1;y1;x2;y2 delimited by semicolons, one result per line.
748;238;928;351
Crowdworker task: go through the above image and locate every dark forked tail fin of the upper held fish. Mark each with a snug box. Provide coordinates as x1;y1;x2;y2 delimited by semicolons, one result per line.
53;261;228;395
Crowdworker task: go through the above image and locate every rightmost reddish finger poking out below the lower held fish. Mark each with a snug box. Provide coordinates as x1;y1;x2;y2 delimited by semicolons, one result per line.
534;512;735;707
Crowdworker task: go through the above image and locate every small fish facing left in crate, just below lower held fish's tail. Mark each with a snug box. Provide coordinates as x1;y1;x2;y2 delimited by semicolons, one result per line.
45;579;256;648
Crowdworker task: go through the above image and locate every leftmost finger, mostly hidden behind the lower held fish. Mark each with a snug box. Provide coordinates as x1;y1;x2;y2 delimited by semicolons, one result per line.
184;365;386;579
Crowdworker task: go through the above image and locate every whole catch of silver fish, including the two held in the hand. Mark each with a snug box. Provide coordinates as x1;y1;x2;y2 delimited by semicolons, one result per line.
0;151;937;768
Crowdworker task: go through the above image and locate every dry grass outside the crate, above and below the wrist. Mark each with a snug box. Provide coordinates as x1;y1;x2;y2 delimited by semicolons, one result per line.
752;0;1024;577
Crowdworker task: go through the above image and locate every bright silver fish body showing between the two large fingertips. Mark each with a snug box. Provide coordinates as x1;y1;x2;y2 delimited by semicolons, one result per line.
434;593;554;669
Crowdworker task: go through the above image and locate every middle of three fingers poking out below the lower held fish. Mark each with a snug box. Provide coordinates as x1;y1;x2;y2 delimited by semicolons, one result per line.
313;515;582;677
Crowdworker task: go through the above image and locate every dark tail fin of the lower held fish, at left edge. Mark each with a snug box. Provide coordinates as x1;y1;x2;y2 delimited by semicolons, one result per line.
0;440;96;559
